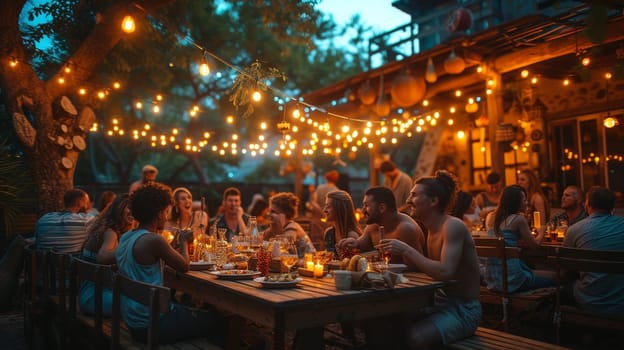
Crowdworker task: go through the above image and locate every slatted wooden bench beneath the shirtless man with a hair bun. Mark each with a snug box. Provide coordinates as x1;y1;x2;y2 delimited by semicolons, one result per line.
446;327;566;350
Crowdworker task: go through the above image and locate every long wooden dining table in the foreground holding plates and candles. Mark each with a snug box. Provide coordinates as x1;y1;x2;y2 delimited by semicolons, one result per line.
165;268;445;349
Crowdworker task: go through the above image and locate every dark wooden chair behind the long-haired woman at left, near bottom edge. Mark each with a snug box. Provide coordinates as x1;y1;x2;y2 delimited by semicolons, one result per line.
69;257;113;349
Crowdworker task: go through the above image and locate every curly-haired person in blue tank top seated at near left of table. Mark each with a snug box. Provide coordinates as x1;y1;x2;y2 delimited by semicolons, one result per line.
115;183;227;344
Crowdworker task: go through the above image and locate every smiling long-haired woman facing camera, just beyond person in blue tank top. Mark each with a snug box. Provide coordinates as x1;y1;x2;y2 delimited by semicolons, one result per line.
165;187;208;238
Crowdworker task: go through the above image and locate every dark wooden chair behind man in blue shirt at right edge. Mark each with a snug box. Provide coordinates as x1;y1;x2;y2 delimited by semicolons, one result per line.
548;247;624;343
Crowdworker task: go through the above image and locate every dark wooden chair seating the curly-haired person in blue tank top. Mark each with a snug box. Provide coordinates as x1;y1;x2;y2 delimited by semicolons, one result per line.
111;274;219;350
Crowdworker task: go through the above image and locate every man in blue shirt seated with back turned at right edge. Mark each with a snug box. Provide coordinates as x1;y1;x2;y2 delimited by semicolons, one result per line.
563;187;624;315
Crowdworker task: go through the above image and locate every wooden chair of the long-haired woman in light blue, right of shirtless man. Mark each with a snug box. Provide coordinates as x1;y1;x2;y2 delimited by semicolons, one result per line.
473;237;555;331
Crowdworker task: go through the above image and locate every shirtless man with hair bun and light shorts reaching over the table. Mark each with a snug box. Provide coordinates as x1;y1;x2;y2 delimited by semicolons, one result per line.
380;171;481;349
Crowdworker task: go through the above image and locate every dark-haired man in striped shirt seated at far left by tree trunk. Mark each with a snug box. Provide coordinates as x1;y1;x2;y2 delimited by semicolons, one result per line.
35;188;93;253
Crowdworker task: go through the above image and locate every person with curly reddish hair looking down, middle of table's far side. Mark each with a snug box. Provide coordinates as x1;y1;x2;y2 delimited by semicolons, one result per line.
264;192;316;258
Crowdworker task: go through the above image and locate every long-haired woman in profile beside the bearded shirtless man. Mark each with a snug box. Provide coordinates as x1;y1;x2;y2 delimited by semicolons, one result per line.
323;190;362;259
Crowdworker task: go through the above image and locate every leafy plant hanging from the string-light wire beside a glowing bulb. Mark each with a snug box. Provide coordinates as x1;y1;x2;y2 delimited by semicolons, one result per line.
229;60;286;118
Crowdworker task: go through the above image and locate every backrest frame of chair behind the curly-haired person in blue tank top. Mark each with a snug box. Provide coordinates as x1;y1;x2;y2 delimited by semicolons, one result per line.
112;274;171;349
